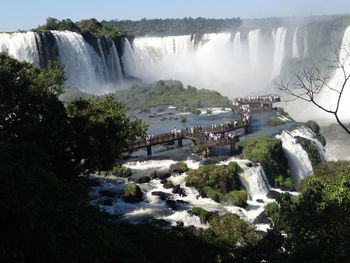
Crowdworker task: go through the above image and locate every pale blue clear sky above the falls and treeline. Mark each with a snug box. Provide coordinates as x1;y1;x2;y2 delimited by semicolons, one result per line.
0;0;350;32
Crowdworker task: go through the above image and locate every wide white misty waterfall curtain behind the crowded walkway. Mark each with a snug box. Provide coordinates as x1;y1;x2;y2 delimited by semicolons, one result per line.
123;28;286;97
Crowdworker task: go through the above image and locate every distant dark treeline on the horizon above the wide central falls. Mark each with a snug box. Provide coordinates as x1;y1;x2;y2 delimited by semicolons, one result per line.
102;17;242;35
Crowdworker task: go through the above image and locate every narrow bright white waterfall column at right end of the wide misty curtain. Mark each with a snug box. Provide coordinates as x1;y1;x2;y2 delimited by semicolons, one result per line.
272;27;287;79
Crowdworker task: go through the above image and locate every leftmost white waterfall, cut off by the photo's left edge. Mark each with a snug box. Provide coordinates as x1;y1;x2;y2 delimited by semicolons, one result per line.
0;32;40;67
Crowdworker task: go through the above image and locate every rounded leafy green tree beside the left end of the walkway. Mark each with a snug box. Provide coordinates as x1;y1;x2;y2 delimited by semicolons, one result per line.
67;95;146;174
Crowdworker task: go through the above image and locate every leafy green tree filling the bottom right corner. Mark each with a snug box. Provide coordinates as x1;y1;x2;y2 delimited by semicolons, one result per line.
272;174;350;262
